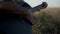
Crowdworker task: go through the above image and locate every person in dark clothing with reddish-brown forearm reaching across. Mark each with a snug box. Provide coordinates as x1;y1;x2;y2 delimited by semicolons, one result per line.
0;0;47;34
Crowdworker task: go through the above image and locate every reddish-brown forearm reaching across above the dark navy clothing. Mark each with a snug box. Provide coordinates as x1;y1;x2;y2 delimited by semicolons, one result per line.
0;2;29;15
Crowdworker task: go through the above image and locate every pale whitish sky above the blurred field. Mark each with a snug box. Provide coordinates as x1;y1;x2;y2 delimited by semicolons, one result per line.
24;0;60;7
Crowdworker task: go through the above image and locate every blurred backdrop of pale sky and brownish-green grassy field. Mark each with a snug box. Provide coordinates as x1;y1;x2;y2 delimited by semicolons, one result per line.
25;0;60;34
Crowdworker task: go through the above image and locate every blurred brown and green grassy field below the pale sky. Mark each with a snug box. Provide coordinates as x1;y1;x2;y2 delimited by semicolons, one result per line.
32;8;60;34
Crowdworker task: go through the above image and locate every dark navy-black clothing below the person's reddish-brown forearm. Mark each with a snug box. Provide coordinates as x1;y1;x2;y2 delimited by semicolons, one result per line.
0;0;32;34
